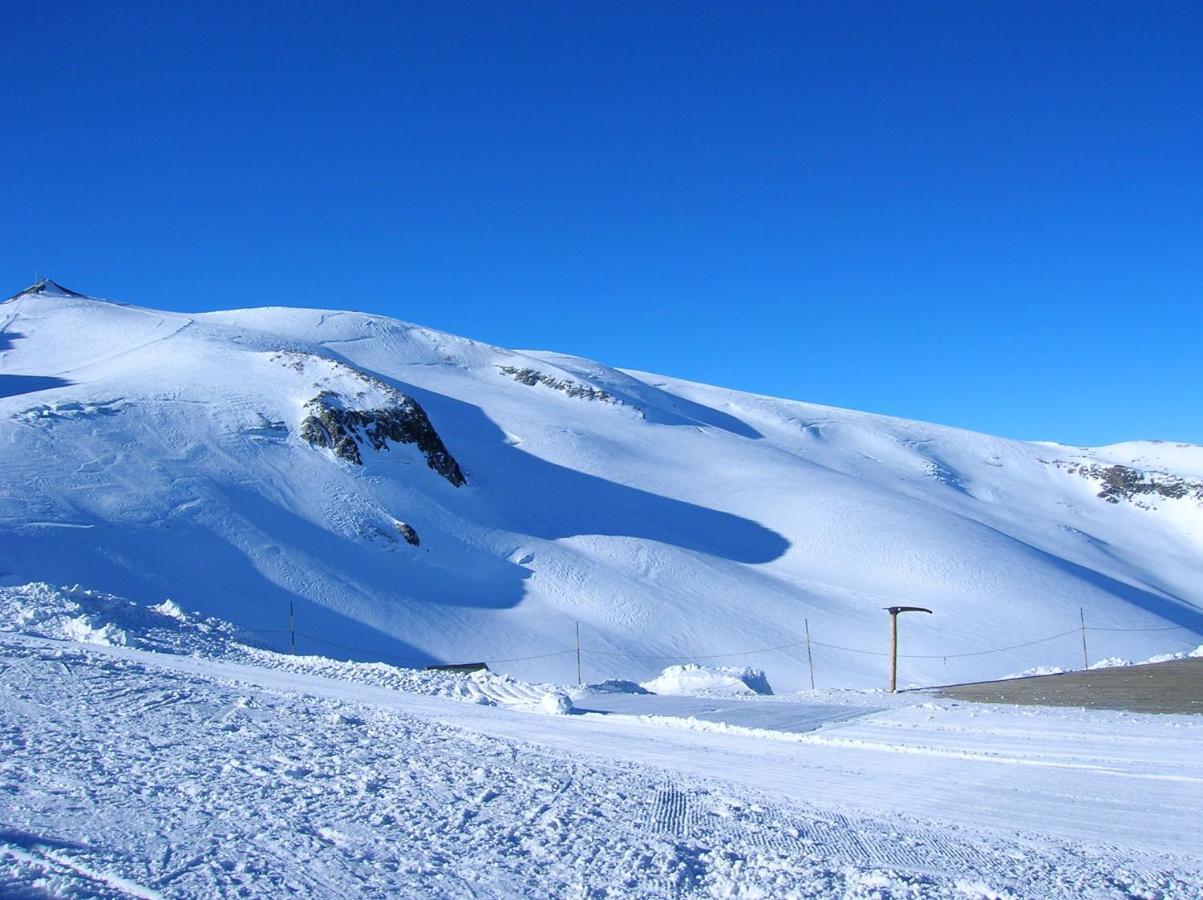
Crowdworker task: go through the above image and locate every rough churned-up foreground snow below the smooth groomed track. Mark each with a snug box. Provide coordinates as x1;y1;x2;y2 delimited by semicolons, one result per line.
0;635;1203;898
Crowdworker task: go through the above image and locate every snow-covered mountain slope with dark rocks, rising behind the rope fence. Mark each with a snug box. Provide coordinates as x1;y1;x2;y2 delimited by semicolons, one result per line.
0;282;1203;691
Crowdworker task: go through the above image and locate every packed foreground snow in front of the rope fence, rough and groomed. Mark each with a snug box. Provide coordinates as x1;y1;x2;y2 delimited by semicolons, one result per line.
0;585;1203;900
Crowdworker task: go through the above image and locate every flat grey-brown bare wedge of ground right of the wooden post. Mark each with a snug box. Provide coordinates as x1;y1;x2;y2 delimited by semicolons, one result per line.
934;658;1203;715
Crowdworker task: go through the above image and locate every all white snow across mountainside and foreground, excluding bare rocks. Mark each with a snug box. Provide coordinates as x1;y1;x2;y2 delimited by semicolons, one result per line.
0;281;1203;899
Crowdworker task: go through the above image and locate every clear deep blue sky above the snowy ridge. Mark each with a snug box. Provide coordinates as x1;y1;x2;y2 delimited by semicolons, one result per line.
0;0;1203;444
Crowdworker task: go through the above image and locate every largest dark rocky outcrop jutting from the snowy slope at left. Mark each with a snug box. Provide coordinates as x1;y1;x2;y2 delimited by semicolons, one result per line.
301;383;467;486
